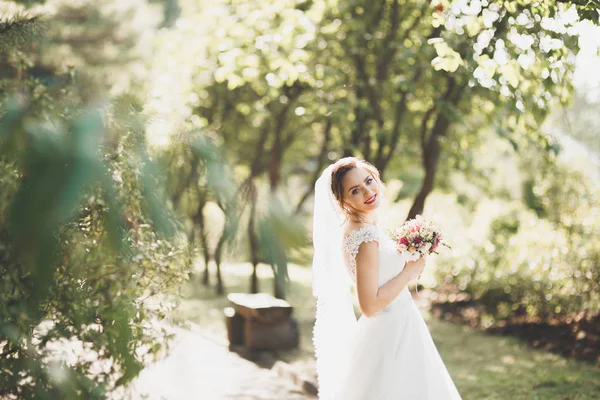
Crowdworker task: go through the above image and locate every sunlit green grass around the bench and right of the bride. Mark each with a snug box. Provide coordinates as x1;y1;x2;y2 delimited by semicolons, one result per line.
174;264;600;400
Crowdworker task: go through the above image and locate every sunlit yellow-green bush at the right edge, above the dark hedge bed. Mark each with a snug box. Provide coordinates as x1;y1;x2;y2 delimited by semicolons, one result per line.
438;155;600;323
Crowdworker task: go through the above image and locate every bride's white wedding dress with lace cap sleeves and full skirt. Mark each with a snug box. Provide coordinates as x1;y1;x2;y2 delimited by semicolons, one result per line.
335;225;460;400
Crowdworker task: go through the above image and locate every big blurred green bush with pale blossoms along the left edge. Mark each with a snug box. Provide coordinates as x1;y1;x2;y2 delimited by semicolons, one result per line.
0;99;188;398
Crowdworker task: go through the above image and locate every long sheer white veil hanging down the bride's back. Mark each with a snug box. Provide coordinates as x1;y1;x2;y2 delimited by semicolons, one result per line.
312;165;356;400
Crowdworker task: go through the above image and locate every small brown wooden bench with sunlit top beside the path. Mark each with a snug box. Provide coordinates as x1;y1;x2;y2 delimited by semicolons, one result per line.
224;293;300;350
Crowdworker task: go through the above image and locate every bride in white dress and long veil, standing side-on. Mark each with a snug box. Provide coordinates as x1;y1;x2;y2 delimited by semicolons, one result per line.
313;157;460;400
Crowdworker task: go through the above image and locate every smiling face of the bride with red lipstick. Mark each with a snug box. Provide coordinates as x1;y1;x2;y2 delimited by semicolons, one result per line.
342;167;380;213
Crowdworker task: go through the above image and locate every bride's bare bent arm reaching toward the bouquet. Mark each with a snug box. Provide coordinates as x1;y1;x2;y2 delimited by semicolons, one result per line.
356;242;425;317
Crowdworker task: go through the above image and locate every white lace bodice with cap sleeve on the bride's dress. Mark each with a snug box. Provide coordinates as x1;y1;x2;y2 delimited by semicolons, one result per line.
342;225;407;286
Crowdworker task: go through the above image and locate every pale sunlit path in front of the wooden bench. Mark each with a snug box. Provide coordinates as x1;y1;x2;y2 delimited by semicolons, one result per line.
126;330;315;400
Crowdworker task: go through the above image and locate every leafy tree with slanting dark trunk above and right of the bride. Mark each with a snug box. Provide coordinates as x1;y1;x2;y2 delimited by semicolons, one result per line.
317;0;577;218
